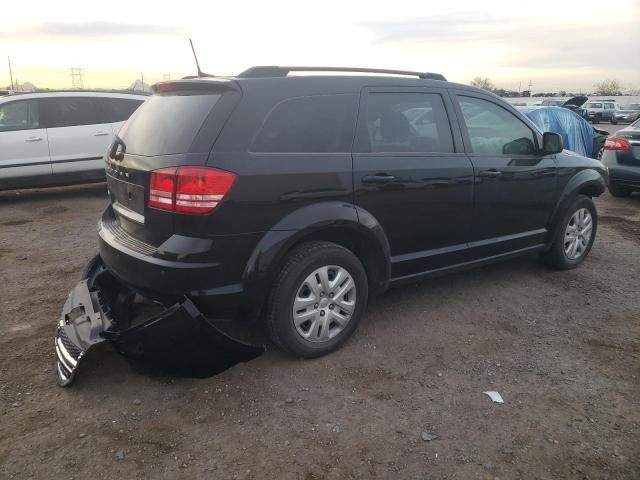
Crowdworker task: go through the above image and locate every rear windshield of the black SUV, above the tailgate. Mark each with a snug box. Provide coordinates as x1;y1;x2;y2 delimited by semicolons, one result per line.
118;95;221;156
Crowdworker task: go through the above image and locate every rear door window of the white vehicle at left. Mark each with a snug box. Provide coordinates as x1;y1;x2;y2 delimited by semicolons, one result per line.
41;97;101;128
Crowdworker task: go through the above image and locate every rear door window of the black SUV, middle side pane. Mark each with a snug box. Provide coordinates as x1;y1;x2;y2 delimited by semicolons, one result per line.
356;92;453;153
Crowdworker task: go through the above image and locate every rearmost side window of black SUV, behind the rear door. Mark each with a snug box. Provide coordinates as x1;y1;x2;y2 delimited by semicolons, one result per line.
250;95;357;153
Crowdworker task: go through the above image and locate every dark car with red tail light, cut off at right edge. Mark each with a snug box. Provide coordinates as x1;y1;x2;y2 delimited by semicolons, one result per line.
602;119;640;197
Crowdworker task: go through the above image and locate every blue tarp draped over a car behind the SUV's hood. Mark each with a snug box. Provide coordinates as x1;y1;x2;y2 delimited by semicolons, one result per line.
521;107;593;157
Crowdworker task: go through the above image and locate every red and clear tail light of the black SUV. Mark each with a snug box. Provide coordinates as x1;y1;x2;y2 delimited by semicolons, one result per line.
149;167;236;213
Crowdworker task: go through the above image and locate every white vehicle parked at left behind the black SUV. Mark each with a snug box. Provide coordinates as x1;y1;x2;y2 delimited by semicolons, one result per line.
0;90;148;190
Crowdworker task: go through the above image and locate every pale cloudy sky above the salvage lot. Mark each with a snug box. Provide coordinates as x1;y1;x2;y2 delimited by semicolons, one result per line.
0;0;640;92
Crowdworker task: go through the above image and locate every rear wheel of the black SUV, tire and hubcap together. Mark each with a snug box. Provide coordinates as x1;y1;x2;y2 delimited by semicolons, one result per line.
266;241;368;358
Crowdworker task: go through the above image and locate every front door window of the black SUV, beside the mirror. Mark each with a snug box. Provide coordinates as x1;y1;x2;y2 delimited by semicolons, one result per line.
457;96;536;155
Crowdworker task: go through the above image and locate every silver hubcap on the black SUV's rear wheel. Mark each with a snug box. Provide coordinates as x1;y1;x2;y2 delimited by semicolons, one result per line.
292;265;356;343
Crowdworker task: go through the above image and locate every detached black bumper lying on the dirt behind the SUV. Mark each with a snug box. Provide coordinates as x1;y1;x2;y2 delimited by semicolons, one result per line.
55;257;264;387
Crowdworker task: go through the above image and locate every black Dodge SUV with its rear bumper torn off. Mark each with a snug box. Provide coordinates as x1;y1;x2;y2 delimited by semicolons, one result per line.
53;67;606;382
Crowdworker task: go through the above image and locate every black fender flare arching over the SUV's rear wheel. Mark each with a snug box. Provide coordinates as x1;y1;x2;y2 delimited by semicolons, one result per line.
242;201;391;310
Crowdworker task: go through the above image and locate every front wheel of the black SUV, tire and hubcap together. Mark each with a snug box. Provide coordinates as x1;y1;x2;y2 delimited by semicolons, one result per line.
542;195;598;270
